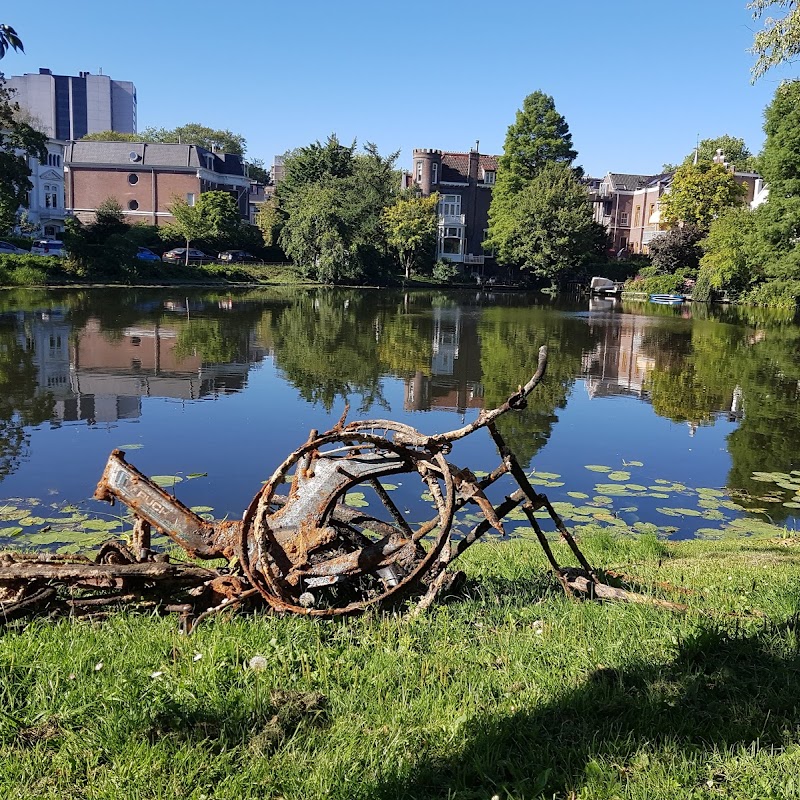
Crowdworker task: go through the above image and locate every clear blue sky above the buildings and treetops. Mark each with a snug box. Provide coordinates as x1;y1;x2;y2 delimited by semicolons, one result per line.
0;0;794;175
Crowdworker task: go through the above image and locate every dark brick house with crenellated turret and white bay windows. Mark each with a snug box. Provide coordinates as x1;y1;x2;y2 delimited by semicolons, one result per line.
403;149;498;273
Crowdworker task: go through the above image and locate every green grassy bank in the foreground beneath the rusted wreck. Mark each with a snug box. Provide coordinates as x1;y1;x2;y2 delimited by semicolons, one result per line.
0;533;800;800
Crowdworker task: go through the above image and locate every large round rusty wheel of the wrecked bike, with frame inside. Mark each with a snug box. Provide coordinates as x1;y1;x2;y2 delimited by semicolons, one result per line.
239;420;455;616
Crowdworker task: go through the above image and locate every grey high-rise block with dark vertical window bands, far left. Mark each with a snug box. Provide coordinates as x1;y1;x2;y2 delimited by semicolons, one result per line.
6;69;136;141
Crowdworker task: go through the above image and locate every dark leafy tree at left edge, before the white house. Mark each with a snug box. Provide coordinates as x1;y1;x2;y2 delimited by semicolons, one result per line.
0;77;47;231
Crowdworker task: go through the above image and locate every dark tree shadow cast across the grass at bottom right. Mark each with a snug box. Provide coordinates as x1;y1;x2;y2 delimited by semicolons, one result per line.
372;620;800;800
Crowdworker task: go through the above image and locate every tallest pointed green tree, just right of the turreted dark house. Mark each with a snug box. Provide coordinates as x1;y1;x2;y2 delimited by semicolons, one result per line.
487;92;596;277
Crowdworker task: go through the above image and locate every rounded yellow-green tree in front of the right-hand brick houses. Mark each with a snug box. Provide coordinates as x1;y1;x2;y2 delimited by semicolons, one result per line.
660;162;746;232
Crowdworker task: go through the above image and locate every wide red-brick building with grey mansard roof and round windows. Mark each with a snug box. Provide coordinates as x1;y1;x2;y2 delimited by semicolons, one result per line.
64;141;251;225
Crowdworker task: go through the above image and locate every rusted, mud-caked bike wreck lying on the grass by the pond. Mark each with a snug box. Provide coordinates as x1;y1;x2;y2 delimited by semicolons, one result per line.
0;347;656;627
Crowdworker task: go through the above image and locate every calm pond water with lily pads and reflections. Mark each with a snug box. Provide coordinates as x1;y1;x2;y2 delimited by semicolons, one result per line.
0;288;800;550
